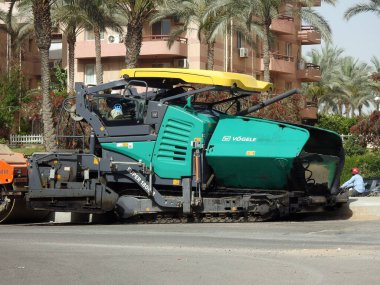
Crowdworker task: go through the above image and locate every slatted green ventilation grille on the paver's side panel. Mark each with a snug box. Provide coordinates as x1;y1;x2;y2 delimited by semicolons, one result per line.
157;119;193;162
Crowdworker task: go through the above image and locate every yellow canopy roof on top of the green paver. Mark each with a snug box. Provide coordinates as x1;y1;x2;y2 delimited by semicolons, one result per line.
120;68;272;92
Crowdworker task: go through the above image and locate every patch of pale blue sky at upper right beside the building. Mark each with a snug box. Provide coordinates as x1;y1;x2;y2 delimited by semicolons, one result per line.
302;0;380;64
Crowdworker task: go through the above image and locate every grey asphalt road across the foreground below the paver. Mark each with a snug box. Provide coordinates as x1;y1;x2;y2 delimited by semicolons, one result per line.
0;216;380;285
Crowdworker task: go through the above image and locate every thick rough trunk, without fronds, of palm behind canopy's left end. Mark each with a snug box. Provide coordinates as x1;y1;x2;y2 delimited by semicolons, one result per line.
124;21;143;68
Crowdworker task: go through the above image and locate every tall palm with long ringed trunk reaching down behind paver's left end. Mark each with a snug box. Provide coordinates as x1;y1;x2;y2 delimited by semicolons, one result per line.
31;0;56;151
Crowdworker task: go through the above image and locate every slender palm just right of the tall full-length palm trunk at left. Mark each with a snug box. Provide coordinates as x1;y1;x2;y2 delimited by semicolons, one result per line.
52;0;84;94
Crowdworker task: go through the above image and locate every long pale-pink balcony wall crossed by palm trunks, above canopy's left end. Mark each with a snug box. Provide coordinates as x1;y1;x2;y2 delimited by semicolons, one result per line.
75;35;187;59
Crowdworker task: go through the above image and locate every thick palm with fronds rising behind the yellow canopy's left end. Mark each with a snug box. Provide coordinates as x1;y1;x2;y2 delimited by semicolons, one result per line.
116;0;160;68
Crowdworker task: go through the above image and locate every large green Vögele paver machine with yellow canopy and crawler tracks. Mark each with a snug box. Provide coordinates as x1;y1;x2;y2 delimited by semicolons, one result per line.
27;68;347;221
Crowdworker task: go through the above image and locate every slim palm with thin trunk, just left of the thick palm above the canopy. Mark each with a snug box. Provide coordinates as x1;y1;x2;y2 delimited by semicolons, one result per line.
76;0;122;84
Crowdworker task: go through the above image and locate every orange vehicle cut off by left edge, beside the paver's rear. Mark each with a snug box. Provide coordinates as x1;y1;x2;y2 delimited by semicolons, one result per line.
0;145;49;223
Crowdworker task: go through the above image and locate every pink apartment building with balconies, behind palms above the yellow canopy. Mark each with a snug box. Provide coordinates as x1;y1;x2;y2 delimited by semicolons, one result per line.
71;0;321;93
